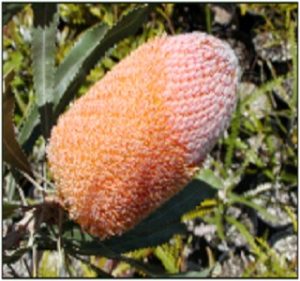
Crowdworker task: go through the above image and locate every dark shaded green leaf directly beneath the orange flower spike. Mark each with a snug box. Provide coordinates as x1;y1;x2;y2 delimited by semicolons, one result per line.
63;180;216;255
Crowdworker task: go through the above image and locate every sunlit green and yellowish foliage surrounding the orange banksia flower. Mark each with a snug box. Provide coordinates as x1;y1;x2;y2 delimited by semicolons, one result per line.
2;3;298;277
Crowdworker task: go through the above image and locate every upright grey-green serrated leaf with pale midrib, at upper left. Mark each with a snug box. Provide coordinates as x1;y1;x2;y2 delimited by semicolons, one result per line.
32;4;58;138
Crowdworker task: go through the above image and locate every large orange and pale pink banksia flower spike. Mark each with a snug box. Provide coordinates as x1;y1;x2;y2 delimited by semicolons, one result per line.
47;33;238;239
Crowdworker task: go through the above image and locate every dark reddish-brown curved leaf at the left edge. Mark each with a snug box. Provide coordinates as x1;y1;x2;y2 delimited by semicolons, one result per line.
3;71;32;175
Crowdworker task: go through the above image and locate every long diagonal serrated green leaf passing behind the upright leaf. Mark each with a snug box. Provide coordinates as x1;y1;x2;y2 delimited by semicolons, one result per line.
15;5;152;151
